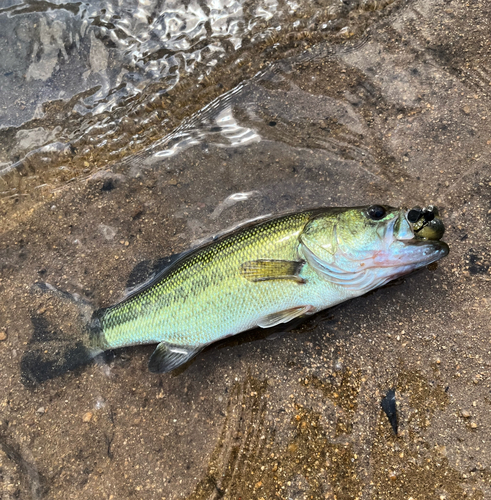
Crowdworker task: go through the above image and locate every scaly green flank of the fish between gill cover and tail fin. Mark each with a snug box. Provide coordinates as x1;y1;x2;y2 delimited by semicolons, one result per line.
101;212;312;348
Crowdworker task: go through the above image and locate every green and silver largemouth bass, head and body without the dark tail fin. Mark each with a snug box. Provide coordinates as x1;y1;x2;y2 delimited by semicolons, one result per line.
90;205;449;372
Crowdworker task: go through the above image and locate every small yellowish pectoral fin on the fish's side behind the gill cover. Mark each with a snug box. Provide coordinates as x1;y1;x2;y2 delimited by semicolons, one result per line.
240;259;305;283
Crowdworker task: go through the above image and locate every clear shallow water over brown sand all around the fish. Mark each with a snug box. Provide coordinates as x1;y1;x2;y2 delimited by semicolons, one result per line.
0;0;491;500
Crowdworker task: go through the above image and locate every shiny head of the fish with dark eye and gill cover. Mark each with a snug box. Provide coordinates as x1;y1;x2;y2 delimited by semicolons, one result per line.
300;205;449;288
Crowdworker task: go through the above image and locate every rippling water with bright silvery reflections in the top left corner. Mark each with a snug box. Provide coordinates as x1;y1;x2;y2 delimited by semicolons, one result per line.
0;0;392;196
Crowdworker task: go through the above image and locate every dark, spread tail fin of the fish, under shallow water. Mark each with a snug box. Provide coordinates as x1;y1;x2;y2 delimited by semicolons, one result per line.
20;283;102;387
